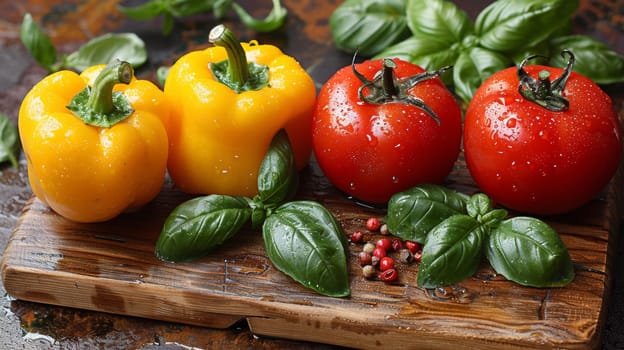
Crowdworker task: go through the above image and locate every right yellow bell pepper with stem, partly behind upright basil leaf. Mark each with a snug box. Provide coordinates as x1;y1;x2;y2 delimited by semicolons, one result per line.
164;26;316;197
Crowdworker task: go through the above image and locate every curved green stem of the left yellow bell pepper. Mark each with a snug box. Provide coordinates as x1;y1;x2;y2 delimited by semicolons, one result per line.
87;61;134;114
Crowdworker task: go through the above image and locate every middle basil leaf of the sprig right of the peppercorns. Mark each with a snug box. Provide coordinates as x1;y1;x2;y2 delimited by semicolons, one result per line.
416;215;485;288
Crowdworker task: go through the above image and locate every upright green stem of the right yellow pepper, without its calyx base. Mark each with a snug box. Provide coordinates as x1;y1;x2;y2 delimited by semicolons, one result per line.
208;24;249;86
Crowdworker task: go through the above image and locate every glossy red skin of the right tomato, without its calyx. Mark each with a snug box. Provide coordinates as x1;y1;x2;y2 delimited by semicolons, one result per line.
464;65;622;215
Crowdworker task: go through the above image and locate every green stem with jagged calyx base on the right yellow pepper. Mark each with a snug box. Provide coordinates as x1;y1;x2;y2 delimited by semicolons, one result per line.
208;24;269;93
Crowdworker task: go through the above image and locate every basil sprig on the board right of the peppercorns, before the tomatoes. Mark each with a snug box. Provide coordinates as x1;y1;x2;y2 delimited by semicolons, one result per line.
386;185;574;288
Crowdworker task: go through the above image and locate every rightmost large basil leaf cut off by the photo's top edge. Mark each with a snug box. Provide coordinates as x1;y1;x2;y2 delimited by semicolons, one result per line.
475;0;579;53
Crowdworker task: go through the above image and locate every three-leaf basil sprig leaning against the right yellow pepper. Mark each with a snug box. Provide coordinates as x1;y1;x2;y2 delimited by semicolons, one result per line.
155;130;350;297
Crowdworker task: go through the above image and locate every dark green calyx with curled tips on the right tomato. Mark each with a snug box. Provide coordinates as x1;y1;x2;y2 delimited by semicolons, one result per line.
518;50;574;112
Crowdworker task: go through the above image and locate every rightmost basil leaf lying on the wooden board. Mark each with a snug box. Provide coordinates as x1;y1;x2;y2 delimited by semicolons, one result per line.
485;217;574;287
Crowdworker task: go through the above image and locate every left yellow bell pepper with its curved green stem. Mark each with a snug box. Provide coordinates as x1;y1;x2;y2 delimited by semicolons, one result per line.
18;62;170;222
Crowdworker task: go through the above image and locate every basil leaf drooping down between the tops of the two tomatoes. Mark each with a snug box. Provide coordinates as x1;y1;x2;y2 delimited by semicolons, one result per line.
453;47;513;103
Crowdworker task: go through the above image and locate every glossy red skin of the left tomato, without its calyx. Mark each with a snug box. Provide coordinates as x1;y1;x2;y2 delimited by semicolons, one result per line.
312;59;462;204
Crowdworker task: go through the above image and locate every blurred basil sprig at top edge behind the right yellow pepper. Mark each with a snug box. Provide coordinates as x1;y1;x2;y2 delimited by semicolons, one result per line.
118;0;288;35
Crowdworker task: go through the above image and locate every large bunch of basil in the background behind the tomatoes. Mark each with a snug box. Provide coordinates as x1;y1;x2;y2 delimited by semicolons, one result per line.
330;0;624;102
